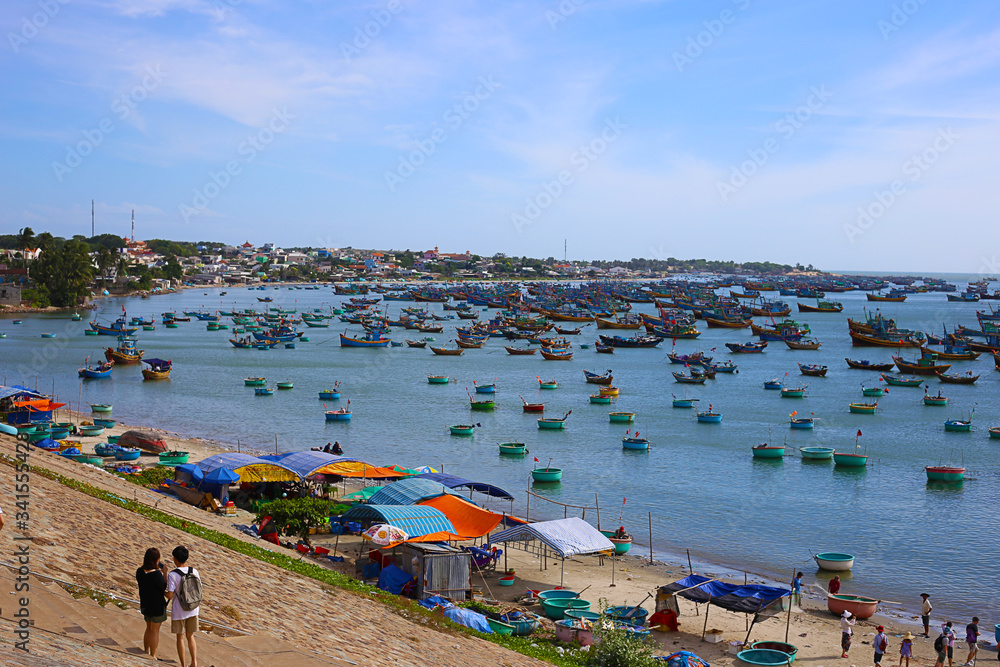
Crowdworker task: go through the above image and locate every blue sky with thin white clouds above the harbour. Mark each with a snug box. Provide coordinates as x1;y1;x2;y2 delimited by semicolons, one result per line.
0;0;1000;274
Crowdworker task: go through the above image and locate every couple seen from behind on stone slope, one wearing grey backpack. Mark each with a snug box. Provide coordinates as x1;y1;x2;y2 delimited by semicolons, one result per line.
135;546;201;667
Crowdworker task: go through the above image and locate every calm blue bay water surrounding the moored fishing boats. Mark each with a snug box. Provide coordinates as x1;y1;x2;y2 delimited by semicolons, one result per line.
0;287;1000;622
